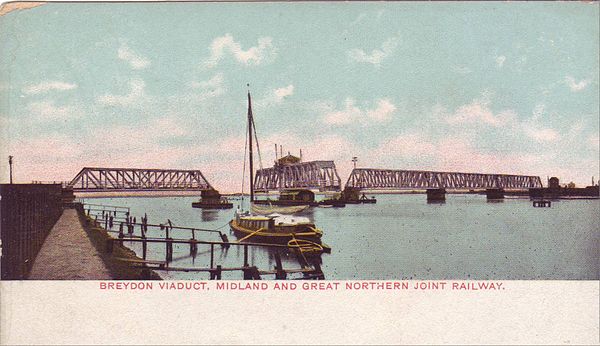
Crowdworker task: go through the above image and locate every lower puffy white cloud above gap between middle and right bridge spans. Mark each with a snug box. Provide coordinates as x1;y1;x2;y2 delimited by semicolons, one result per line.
323;98;396;125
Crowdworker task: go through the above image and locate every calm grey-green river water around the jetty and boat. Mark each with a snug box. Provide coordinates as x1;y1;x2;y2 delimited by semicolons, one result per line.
85;195;600;280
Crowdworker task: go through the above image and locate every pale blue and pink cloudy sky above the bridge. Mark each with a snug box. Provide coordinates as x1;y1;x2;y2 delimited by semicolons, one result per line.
0;2;600;192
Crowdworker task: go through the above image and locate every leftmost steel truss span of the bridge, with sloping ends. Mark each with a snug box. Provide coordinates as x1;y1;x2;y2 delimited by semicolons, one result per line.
69;167;212;192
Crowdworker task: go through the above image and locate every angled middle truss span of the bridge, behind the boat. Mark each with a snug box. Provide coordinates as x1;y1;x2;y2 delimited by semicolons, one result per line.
254;161;341;191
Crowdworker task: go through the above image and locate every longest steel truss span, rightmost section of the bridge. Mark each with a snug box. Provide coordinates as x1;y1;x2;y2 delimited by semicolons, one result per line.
346;168;542;190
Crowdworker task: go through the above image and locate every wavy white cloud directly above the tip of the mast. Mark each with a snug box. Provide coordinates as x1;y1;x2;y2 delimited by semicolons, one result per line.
203;34;277;68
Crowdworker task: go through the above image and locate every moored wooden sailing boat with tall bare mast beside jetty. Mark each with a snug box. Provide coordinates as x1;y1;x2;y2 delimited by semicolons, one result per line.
229;86;330;252
